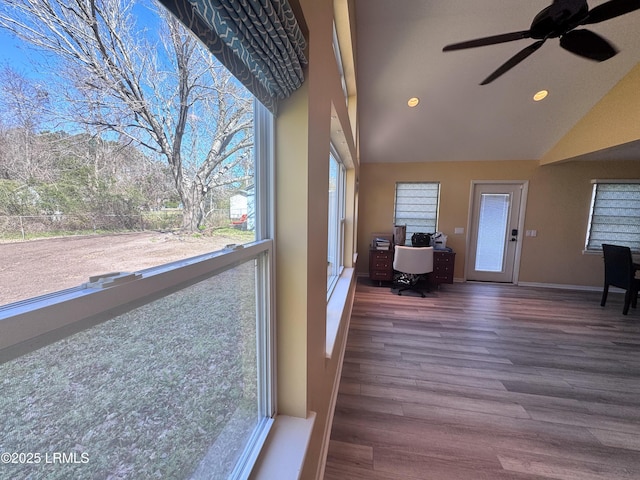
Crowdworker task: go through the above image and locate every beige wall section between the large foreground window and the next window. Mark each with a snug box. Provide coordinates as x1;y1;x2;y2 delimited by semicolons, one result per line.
275;0;357;479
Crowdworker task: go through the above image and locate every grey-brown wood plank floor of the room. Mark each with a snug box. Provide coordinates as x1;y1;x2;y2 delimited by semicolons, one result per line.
324;279;640;480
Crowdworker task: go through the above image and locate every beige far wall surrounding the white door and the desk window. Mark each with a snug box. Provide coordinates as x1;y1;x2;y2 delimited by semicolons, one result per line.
358;159;640;286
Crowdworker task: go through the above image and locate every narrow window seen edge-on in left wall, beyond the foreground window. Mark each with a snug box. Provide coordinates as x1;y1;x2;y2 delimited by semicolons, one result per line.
327;149;345;295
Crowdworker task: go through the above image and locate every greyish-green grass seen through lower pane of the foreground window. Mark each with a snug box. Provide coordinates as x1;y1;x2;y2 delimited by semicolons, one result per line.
0;262;257;480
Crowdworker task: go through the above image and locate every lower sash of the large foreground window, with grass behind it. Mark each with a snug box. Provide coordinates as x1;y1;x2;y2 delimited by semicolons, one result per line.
0;104;275;478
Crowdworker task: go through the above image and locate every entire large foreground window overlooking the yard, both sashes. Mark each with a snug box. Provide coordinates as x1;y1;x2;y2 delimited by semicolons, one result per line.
0;0;275;478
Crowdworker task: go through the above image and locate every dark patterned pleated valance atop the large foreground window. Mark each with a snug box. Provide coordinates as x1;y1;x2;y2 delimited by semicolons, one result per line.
162;0;307;113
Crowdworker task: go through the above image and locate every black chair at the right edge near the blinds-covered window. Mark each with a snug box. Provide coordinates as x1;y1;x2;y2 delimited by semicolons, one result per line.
600;243;640;315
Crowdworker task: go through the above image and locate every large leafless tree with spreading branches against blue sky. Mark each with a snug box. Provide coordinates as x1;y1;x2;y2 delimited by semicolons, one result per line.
0;0;253;230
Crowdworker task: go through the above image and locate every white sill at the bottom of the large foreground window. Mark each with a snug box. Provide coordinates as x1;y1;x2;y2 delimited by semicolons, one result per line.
249;412;316;480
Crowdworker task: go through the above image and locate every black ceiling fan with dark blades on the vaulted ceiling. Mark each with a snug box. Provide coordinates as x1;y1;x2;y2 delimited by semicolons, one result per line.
442;0;640;85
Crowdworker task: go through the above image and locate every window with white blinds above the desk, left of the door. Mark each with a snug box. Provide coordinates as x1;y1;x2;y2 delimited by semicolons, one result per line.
394;182;440;245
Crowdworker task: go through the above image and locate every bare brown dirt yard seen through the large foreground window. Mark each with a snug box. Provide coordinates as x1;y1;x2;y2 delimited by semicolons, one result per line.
0;232;242;306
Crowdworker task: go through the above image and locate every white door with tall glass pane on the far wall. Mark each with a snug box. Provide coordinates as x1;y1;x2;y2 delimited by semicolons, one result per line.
467;182;526;283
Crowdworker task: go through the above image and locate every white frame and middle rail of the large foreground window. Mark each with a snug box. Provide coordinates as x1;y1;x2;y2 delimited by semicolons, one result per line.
0;99;277;478
